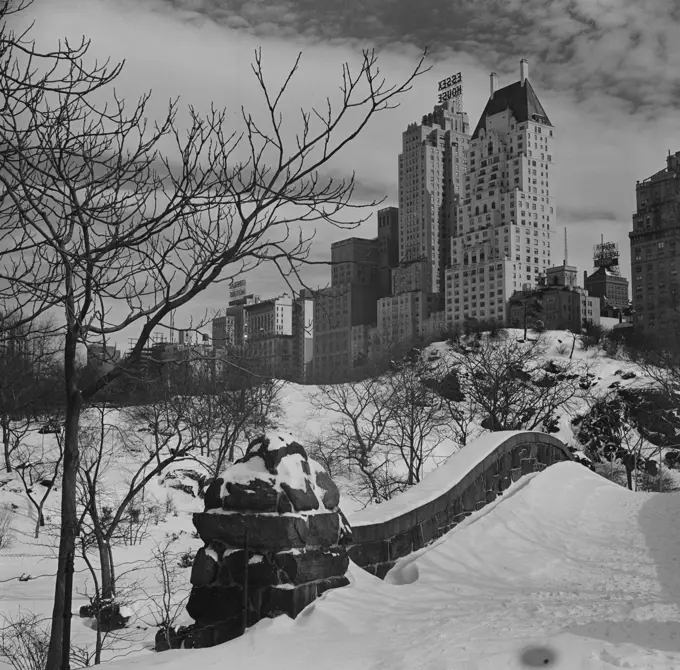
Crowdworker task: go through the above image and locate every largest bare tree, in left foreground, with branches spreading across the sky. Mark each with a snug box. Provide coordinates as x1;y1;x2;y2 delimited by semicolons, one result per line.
0;3;424;670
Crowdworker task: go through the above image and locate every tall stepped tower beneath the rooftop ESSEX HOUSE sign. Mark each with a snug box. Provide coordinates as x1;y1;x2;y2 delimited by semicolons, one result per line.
399;100;470;293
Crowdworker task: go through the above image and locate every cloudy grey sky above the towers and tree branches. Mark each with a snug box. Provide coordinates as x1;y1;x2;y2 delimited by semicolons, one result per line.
19;0;680;346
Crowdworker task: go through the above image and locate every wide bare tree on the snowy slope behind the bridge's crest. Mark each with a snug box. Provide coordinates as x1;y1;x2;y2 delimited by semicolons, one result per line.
456;336;589;430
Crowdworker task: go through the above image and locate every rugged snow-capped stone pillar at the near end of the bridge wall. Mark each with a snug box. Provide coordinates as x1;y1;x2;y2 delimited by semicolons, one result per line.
165;435;351;648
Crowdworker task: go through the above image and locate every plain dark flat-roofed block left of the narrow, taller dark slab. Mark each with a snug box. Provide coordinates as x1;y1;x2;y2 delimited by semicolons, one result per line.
313;237;379;381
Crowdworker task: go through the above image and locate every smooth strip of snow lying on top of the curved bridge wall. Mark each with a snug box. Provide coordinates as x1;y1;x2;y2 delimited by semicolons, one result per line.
348;430;524;526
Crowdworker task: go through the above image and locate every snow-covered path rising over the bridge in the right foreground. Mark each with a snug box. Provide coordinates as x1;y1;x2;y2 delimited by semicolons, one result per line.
105;463;680;670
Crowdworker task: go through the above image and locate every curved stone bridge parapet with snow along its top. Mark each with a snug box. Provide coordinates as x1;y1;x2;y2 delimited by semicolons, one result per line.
347;431;573;579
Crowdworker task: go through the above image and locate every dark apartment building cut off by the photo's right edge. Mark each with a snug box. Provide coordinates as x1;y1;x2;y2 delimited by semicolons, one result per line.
628;151;680;334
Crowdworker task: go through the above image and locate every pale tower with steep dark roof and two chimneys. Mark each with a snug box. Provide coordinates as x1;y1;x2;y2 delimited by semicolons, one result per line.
446;59;556;325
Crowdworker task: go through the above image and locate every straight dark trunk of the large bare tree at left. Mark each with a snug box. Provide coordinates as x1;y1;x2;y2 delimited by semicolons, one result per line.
45;329;83;670
